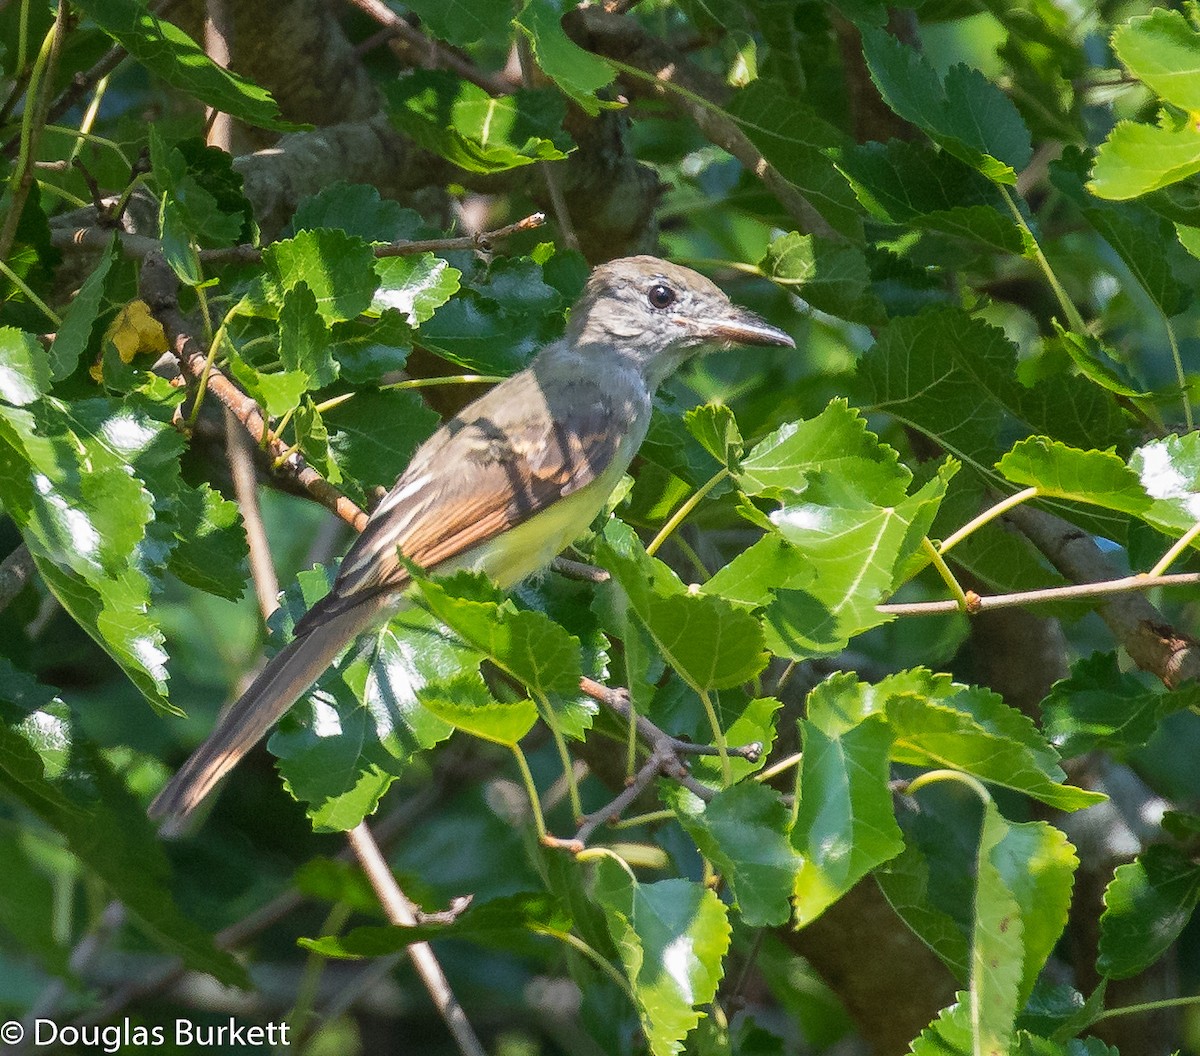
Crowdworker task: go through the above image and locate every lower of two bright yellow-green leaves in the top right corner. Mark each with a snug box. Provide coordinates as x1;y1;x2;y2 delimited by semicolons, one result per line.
1087;121;1200;200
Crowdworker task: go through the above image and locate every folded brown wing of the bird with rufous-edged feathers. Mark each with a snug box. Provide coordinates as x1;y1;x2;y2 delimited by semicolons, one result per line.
311;371;629;619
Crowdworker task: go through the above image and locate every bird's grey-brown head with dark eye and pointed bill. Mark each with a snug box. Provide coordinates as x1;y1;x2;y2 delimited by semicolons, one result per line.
566;257;796;388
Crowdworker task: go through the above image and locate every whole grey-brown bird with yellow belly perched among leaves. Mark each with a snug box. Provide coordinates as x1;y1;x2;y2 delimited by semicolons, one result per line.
150;256;796;834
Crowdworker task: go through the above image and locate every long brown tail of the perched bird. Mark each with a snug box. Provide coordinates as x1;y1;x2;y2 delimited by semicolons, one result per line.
150;601;379;835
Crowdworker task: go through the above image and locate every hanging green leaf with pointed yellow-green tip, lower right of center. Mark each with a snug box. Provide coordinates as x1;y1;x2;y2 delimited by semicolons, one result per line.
792;715;904;926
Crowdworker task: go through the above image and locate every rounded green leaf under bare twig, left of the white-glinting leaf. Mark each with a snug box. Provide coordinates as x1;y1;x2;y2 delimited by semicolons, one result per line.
263;228;378;323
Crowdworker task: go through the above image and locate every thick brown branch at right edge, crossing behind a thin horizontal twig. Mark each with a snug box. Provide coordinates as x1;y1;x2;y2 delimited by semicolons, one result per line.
1004;506;1200;689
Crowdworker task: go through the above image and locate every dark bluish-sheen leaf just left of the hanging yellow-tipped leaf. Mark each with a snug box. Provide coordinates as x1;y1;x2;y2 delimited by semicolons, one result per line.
667;781;800;928
